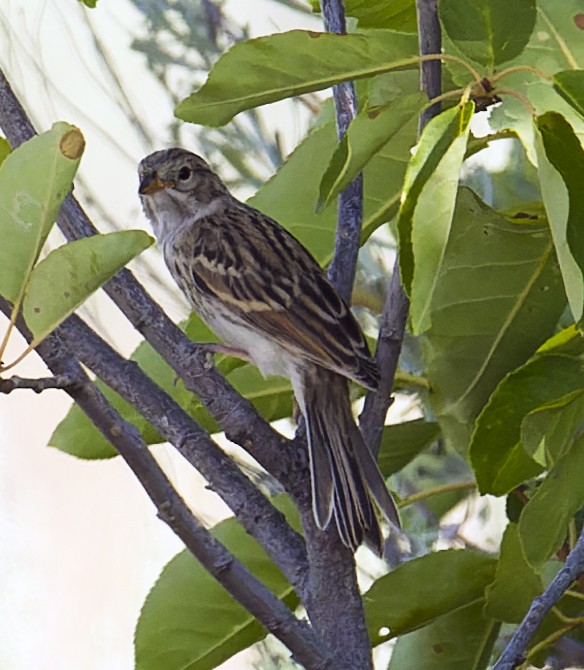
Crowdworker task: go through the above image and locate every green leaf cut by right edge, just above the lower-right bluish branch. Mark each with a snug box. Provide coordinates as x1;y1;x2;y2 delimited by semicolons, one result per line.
519;436;584;568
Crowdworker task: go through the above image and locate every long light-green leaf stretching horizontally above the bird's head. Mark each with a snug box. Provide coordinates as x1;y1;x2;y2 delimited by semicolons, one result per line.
175;30;418;126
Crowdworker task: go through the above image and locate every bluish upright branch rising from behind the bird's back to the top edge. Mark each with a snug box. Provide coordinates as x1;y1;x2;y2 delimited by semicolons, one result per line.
321;0;363;303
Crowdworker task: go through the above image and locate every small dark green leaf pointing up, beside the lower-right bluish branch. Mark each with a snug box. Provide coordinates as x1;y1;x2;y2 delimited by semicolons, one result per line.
484;523;543;623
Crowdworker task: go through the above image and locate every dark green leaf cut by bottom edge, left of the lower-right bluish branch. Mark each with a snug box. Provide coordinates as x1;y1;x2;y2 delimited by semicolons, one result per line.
388;600;500;670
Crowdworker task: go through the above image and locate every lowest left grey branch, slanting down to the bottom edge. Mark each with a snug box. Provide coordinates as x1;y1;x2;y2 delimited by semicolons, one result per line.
0;300;333;670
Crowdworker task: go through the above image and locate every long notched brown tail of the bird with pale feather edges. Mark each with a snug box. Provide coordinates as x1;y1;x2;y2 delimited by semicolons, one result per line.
295;366;399;554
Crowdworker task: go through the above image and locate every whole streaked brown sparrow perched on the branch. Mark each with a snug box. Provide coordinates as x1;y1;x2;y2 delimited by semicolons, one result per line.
138;148;399;554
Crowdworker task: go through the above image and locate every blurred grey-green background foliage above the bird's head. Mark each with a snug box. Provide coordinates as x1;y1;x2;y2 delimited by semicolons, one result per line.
130;0;314;189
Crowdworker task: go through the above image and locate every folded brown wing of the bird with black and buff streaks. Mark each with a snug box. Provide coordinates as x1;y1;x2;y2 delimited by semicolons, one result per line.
192;206;379;388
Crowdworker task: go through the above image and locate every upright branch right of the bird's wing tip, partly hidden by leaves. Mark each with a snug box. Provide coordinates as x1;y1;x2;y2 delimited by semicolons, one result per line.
360;0;442;454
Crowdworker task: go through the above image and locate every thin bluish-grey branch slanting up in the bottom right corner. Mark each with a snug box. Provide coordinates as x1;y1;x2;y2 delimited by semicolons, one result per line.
493;530;584;670
